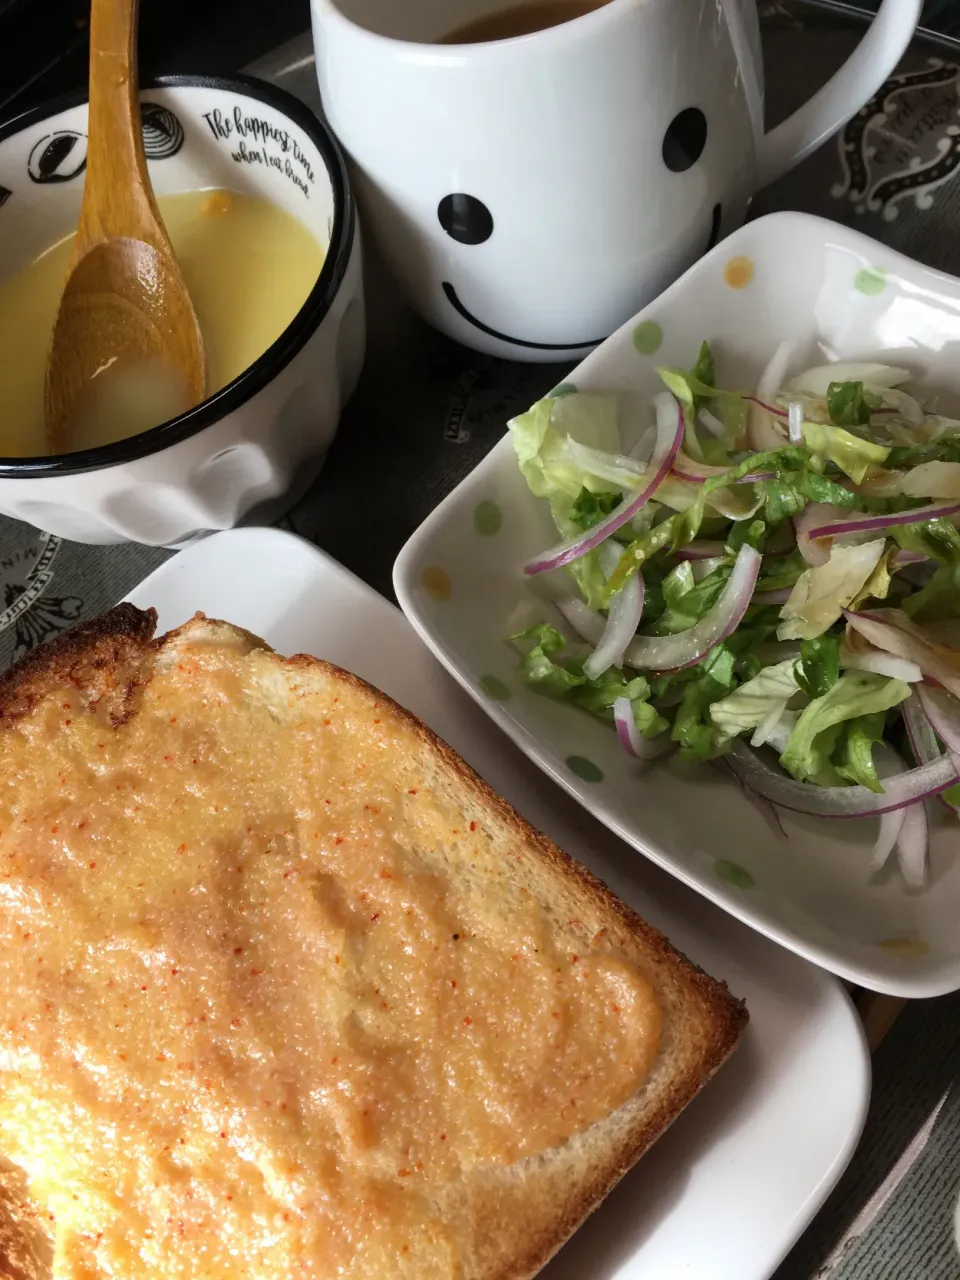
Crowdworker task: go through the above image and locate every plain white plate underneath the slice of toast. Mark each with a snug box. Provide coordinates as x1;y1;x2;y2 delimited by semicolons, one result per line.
131;529;869;1280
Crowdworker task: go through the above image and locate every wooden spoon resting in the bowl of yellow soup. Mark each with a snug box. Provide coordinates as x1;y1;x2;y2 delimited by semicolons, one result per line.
45;0;206;453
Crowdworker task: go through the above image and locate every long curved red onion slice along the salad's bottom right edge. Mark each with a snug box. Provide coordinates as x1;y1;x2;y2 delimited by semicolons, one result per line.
728;739;960;818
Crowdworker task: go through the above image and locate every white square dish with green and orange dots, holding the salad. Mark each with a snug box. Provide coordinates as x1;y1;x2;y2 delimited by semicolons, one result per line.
394;214;960;997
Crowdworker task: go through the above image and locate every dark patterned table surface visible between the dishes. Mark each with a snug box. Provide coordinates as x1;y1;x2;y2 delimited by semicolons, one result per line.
0;0;960;1280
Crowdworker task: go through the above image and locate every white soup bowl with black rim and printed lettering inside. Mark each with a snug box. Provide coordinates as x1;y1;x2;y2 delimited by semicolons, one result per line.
0;76;365;547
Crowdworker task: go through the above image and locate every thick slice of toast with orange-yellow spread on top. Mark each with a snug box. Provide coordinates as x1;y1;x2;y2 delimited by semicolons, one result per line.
0;605;746;1280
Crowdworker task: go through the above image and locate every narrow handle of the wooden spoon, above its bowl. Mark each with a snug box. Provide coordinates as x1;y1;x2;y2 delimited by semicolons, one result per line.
74;0;172;260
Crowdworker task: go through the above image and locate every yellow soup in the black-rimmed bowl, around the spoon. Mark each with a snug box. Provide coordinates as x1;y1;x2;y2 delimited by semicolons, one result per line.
0;191;324;457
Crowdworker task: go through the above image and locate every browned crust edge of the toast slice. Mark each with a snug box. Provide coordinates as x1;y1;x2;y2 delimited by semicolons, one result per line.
0;604;748;1280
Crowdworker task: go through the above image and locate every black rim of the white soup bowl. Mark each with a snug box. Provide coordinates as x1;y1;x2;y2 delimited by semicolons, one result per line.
0;76;356;480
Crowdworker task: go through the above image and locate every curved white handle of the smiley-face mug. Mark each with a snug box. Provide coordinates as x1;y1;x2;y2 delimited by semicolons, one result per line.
756;0;923;189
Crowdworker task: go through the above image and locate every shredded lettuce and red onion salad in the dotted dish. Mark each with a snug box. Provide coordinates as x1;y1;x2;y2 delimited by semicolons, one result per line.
509;343;960;888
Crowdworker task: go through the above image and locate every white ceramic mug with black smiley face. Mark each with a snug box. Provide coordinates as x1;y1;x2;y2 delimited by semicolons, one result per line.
312;0;920;361
